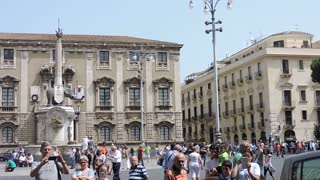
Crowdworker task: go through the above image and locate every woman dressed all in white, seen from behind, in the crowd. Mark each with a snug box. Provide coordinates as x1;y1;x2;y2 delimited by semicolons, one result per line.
187;147;203;180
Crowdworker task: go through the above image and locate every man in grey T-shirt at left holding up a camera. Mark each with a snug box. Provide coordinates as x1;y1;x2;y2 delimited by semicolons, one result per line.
30;142;69;180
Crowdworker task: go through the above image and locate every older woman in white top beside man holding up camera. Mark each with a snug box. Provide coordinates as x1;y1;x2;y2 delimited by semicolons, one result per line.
72;156;94;180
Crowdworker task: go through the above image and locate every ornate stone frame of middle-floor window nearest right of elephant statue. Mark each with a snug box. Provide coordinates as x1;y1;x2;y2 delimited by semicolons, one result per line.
94;76;115;112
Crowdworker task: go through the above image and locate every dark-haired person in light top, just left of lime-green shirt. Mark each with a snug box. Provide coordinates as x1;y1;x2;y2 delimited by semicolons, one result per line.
206;144;219;180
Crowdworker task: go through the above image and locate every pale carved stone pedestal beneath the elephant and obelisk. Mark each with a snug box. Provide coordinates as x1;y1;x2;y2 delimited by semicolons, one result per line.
36;106;76;145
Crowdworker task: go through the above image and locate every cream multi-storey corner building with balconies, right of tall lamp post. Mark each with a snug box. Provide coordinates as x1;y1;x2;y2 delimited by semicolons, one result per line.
181;31;320;144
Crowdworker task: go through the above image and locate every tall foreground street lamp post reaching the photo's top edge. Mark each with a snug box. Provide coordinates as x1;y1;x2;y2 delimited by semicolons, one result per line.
189;0;232;145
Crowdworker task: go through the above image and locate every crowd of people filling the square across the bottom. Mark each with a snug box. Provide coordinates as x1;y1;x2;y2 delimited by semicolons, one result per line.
6;137;319;180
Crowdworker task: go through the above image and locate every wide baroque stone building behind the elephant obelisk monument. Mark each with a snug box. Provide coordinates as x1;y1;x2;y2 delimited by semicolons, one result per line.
0;33;183;146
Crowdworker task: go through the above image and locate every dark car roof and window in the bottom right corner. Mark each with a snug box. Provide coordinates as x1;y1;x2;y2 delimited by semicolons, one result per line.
280;151;320;180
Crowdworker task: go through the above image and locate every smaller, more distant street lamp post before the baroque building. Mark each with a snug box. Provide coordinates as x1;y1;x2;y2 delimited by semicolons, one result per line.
133;48;153;145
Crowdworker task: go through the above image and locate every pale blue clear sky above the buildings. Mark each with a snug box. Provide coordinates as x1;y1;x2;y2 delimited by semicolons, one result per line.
0;0;320;80
